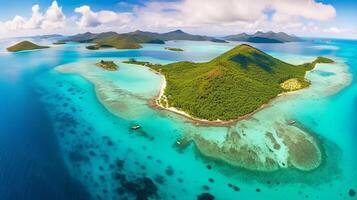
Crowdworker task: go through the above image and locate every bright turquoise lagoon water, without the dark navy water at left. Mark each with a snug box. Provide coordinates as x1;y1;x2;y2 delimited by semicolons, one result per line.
0;38;357;199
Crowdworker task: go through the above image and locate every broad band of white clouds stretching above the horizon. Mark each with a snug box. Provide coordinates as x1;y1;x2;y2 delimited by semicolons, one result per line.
0;0;356;36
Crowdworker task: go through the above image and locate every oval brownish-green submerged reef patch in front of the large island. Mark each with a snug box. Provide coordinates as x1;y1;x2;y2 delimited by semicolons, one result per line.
188;120;322;171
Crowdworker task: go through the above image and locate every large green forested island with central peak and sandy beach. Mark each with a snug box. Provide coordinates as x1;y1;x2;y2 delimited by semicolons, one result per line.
127;45;333;123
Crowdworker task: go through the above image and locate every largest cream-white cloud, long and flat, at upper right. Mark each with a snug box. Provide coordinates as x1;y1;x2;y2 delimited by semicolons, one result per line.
130;0;336;26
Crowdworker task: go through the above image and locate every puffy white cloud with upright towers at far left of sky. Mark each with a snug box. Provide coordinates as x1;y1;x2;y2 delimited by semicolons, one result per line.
5;1;66;30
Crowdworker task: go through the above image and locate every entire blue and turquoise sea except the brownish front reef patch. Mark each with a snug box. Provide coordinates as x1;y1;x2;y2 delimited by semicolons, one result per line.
0;39;357;200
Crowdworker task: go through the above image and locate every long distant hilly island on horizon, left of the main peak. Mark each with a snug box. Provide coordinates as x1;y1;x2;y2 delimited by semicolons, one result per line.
60;30;226;50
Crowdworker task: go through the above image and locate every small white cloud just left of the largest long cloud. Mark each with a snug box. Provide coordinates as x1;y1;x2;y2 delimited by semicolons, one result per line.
75;5;132;28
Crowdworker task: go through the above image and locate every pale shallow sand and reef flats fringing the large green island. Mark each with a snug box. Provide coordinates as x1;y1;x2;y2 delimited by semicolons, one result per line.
57;55;351;171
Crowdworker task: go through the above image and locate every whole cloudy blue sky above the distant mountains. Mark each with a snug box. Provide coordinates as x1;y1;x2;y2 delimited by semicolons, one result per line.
0;0;357;39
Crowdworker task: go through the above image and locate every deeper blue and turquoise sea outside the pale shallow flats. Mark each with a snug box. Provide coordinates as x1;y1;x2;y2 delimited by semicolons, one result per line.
0;39;357;200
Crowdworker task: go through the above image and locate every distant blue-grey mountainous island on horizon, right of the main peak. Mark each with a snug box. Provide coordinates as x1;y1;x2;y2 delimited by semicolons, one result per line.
224;31;303;43
